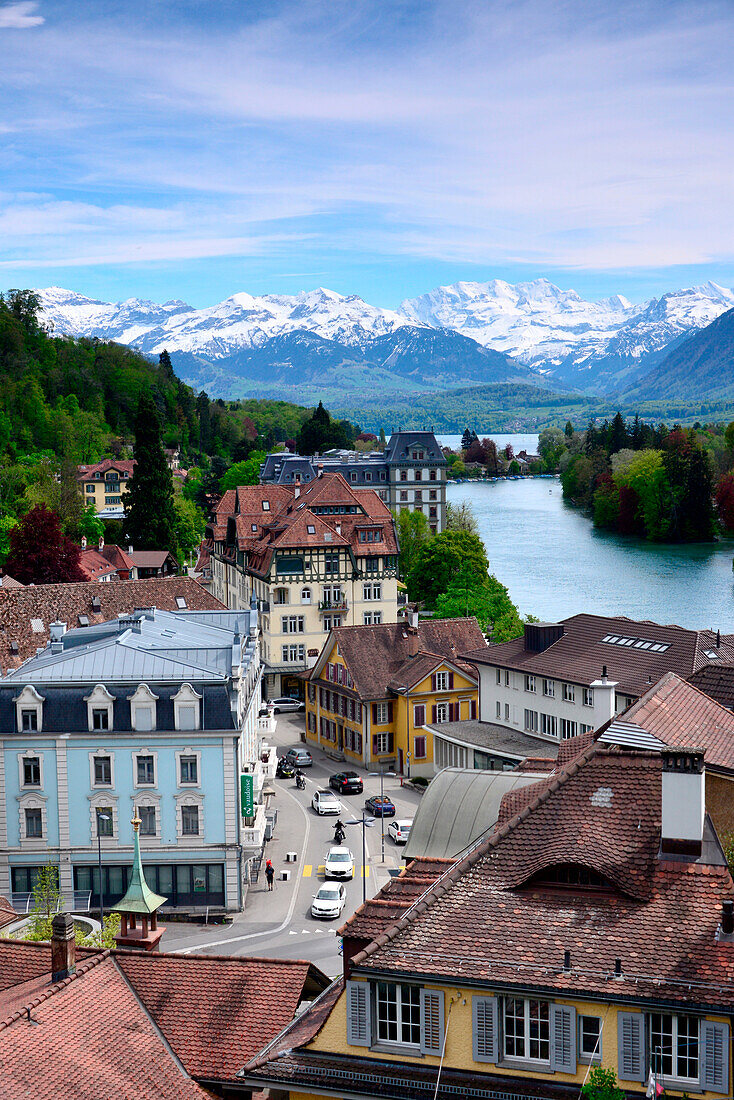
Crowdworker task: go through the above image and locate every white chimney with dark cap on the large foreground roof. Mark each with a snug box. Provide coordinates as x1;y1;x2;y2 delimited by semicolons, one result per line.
660;749;706;859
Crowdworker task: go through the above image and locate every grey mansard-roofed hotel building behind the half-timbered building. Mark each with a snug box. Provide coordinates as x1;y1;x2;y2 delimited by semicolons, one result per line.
260;431;447;535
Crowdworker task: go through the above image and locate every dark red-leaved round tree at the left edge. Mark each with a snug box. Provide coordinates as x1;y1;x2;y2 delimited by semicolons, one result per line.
4;504;86;584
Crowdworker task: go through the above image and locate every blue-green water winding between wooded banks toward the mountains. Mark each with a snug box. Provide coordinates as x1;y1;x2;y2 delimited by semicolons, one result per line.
448;477;734;634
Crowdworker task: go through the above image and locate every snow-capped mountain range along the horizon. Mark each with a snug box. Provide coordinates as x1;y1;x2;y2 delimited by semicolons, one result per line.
36;279;734;408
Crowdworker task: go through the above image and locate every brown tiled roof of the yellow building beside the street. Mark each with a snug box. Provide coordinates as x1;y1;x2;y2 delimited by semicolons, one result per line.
319;616;484;700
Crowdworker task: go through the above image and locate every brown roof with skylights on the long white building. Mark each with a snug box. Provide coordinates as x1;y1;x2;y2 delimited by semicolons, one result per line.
467;614;734;695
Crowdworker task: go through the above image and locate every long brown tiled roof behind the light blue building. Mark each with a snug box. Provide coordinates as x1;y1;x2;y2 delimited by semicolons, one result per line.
0;576;224;670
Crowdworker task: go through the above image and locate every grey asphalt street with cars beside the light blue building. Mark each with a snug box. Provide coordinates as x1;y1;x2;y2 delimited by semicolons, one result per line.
163;713;420;977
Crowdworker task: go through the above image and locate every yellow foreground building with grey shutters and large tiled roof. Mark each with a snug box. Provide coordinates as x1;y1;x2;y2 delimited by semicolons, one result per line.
242;730;734;1100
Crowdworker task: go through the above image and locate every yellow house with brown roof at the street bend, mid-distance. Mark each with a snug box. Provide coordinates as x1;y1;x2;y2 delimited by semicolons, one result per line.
306;614;485;777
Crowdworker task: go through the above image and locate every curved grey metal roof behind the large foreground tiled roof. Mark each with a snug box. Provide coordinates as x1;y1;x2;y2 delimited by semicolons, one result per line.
403;768;548;859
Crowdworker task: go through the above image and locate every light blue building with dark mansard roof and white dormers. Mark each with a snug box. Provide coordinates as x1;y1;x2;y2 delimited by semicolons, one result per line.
0;608;267;910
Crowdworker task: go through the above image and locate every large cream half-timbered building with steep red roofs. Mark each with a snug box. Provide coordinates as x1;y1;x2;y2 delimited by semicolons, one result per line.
207;474;398;699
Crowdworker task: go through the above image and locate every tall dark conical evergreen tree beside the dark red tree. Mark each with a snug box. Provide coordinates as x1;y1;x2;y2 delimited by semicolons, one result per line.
123;394;176;554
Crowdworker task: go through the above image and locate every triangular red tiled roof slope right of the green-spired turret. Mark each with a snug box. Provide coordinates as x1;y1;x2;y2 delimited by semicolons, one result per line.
116;952;326;1080
